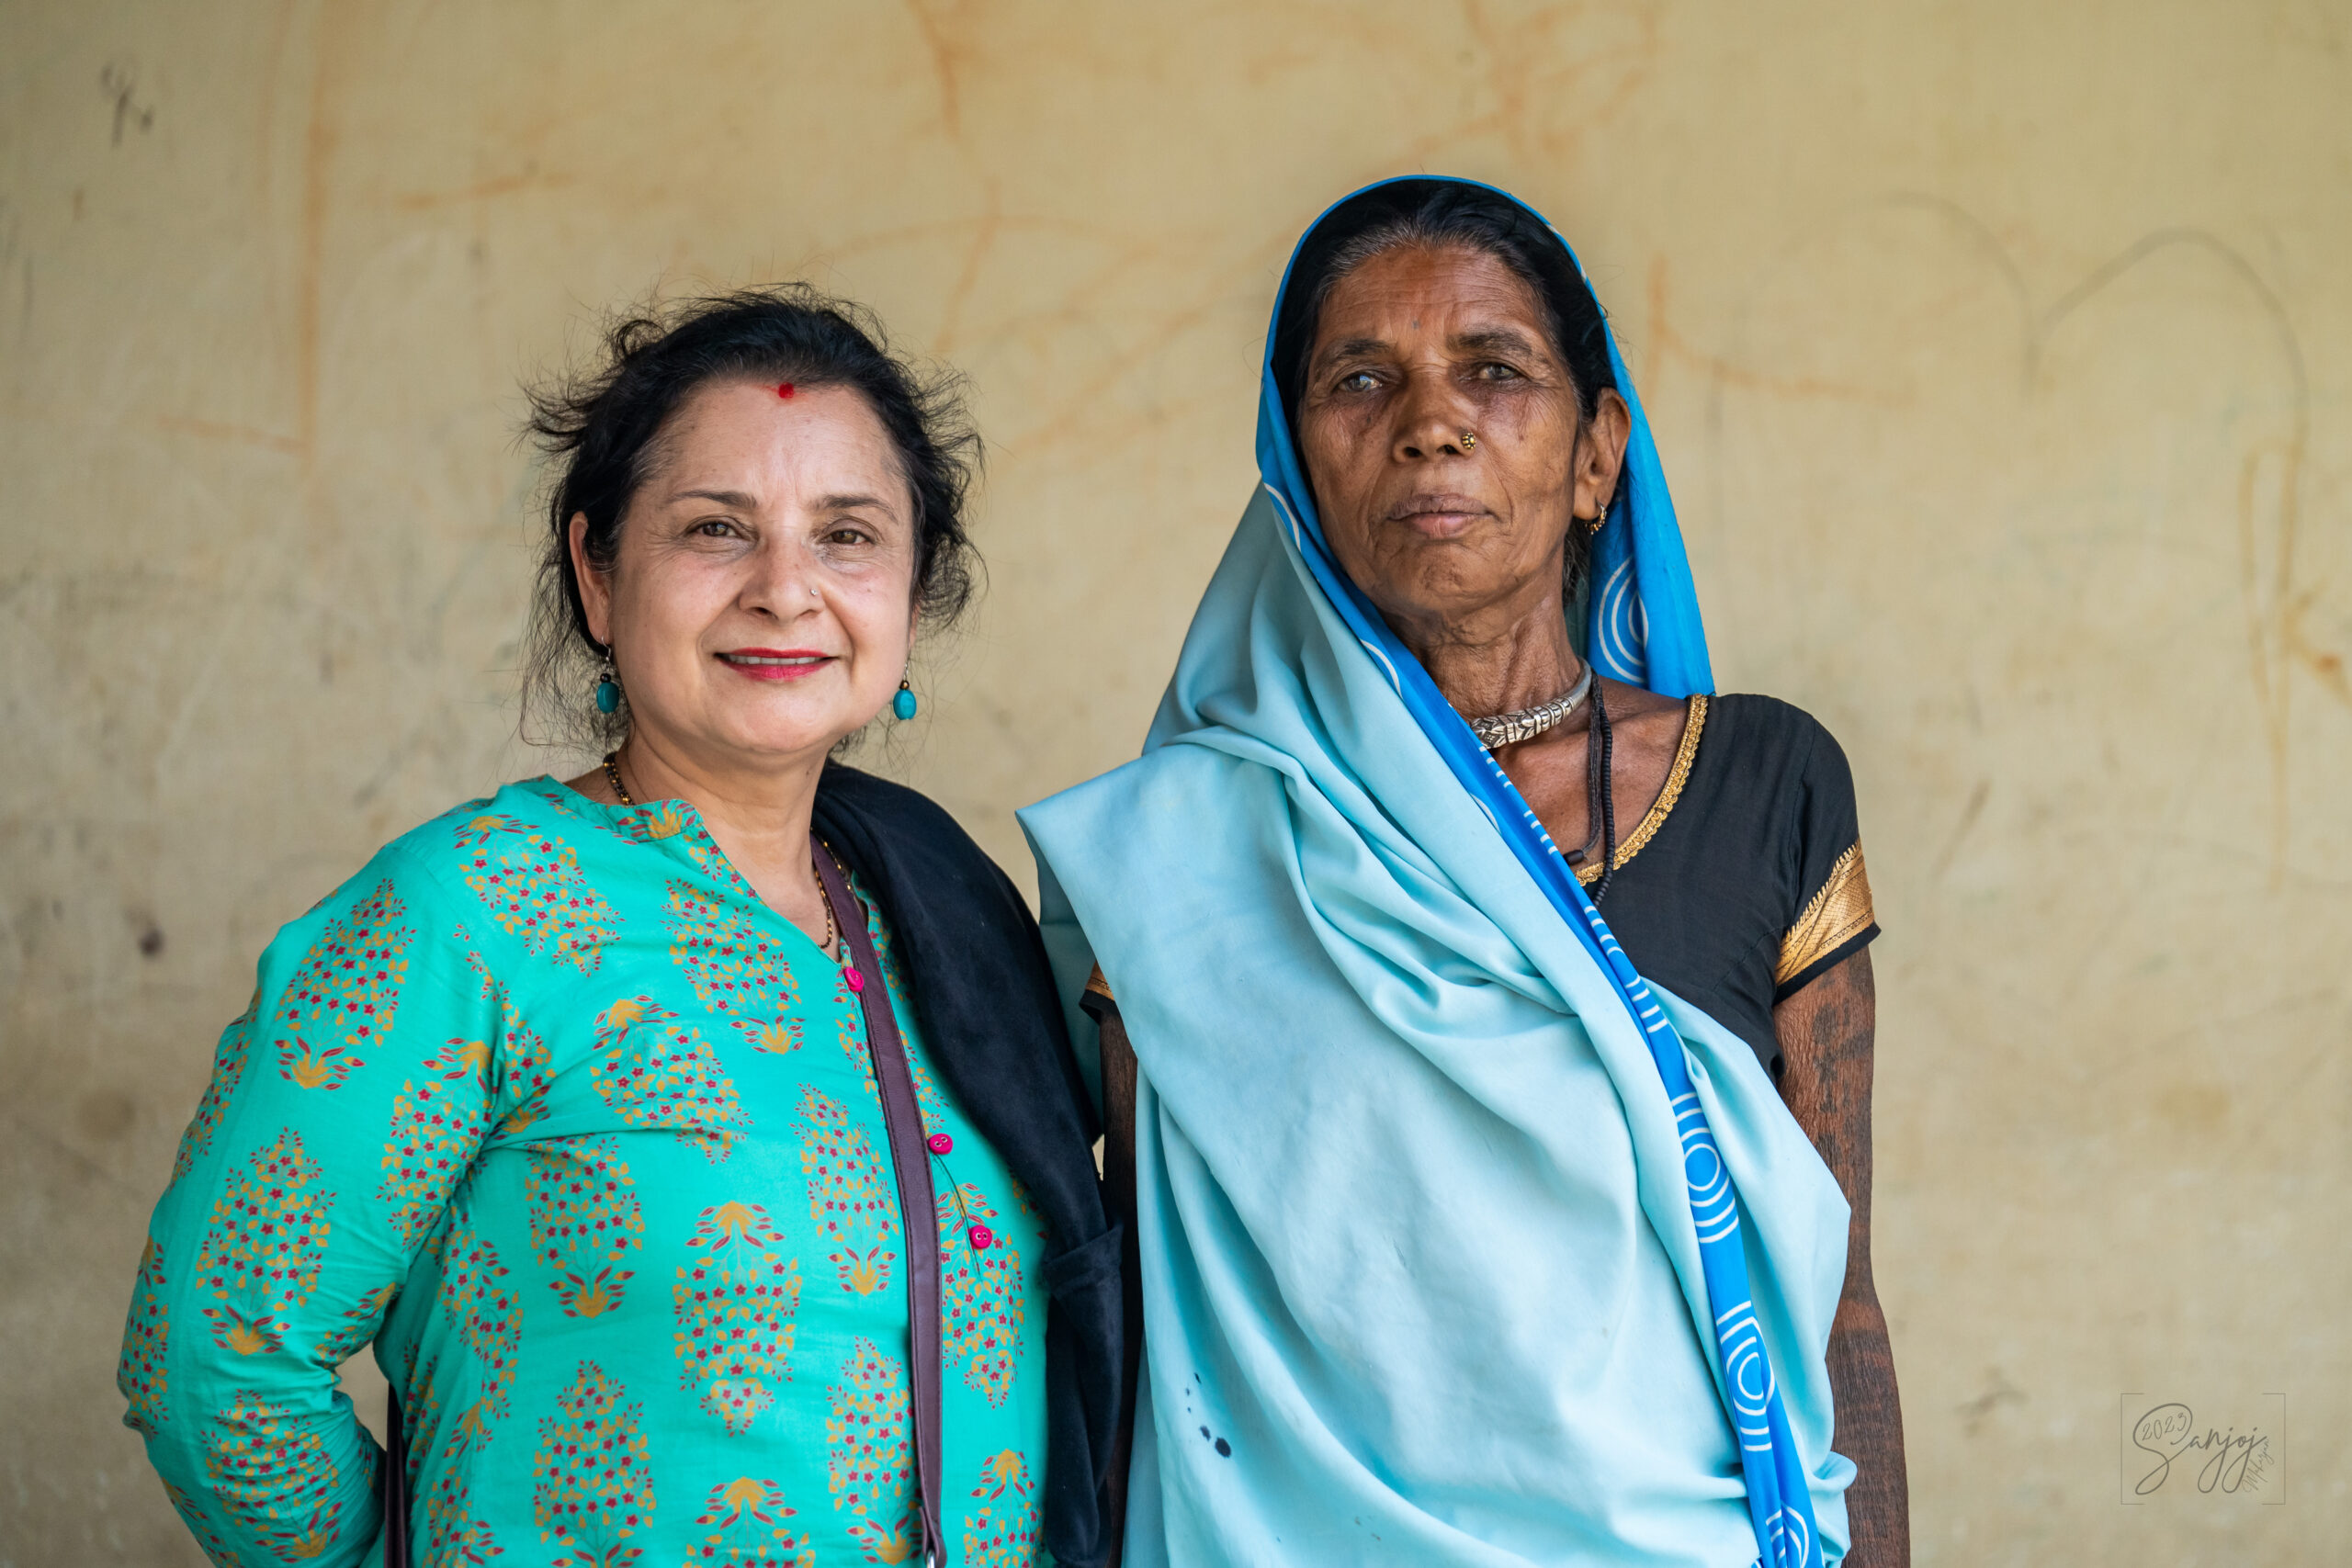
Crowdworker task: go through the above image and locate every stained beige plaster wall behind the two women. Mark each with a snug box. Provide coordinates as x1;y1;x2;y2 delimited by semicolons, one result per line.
0;0;2352;1568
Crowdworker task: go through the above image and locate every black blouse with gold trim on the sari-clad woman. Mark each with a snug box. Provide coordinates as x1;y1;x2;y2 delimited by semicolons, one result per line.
1578;696;1879;1072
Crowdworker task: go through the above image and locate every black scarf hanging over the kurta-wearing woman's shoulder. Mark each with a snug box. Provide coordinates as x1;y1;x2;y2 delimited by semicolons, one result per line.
816;764;1125;1568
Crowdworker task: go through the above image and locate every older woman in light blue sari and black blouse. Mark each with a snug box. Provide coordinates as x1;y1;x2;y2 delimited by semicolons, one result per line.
1023;179;1907;1568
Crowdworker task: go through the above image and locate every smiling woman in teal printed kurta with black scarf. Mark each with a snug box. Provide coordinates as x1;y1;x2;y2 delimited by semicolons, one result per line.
120;291;1122;1568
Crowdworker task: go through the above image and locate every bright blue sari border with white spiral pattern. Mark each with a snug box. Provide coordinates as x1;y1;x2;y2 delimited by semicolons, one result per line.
1259;171;1826;1568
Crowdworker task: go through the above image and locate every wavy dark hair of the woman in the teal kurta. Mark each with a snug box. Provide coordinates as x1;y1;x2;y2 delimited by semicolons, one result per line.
522;285;981;750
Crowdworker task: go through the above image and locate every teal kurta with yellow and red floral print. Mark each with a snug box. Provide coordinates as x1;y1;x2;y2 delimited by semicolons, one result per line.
120;778;1045;1568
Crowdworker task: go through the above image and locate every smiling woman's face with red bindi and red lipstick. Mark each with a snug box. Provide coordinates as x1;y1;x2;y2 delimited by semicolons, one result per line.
571;381;915;766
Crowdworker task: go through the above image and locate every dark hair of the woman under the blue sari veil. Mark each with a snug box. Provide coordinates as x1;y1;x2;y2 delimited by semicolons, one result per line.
1275;179;1633;600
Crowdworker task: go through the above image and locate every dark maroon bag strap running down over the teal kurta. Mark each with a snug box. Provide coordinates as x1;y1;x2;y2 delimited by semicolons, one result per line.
809;832;945;1563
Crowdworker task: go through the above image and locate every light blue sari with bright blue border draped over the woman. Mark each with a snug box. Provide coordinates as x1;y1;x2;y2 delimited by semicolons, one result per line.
1021;181;1853;1568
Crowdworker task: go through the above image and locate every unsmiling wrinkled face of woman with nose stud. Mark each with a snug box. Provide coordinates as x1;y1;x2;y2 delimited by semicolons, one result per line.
1298;244;1623;637
